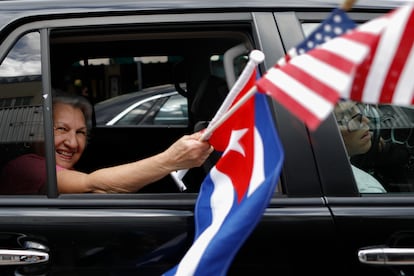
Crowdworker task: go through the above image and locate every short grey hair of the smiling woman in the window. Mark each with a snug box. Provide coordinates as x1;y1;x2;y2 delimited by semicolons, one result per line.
52;90;93;133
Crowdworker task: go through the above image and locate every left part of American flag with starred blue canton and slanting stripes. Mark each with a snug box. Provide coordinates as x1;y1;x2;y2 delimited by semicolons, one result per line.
257;9;356;129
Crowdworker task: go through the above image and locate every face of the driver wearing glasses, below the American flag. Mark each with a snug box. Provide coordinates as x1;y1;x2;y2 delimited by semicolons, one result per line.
336;103;371;156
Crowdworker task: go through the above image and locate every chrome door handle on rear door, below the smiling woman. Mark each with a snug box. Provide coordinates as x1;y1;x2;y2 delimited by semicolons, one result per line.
0;249;49;265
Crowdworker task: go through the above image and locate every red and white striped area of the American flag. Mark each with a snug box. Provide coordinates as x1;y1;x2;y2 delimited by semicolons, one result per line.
256;5;414;130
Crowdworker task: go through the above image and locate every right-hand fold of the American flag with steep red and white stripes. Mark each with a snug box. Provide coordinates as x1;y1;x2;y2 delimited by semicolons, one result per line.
348;4;414;105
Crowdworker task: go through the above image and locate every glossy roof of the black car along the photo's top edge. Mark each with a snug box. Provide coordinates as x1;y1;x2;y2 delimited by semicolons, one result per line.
0;0;411;30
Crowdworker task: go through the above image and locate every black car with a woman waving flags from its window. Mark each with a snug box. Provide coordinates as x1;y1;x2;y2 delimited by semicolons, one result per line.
0;0;414;275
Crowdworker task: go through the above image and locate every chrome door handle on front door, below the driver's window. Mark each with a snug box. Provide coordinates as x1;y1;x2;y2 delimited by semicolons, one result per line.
358;247;414;265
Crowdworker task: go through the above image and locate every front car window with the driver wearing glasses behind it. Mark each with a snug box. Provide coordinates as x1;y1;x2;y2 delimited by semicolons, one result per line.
301;22;414;194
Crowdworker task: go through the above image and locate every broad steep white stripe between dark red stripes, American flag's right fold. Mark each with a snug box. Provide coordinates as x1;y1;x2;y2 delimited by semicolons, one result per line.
362;6;411;103
